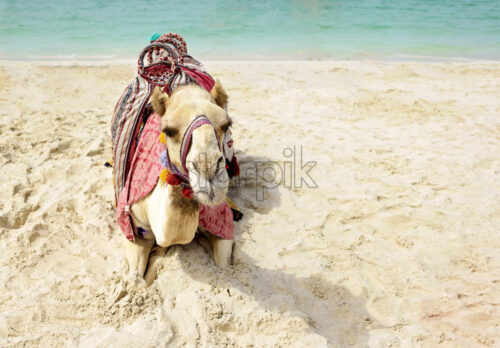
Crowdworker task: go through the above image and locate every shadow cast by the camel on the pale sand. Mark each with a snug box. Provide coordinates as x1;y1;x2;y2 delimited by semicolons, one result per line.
172;152;379;346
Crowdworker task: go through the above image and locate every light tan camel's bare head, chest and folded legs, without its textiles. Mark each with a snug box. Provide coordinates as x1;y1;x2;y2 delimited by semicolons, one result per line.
125;81;233;285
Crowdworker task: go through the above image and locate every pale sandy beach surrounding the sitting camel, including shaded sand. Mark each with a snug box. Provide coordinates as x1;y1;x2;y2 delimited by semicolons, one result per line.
0;61;500;347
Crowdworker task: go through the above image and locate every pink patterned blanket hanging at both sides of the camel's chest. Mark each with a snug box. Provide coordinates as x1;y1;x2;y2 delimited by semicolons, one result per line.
116;113;234;240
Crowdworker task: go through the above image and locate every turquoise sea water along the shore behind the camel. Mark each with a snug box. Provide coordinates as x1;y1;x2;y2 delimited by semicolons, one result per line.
0;0;500;60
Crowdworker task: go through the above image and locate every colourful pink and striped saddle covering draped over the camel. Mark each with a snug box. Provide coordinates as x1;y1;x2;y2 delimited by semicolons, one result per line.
111;33;234;240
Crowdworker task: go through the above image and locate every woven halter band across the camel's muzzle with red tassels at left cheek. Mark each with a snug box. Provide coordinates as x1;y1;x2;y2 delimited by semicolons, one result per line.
160;115;221;198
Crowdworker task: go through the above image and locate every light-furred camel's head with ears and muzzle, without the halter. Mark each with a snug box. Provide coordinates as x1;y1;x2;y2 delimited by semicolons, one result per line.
151;81;231;205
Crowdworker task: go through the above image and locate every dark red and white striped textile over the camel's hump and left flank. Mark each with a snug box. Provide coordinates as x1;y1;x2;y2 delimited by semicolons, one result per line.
111;33;215;202
